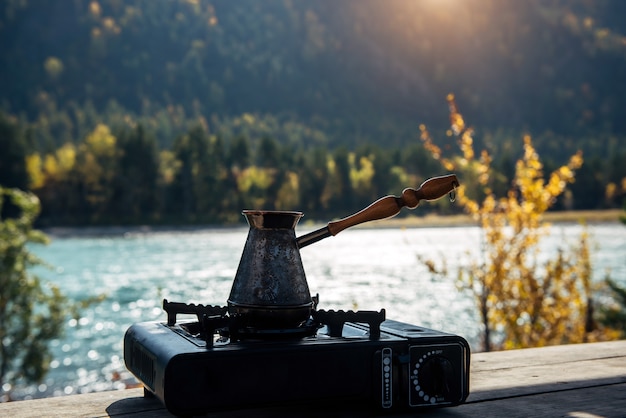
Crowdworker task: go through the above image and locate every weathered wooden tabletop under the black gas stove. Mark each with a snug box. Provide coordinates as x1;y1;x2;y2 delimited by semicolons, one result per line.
0;341;626;418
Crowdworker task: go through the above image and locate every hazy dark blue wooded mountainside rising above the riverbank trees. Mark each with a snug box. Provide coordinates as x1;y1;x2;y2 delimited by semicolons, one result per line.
0;0;626;150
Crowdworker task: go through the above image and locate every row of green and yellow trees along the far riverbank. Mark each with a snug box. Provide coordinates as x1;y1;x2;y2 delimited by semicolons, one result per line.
0;115;626;226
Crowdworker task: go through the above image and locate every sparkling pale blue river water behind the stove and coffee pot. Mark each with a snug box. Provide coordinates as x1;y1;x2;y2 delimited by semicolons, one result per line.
4;222;626;399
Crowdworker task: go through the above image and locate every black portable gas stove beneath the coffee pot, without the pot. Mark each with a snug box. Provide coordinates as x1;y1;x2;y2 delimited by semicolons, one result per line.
124;301;470;415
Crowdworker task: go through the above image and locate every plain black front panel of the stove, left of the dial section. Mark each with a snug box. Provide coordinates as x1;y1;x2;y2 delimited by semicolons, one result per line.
164;344;394;414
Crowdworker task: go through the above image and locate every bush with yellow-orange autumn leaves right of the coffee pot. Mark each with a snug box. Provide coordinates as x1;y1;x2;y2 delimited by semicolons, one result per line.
420;95;608;351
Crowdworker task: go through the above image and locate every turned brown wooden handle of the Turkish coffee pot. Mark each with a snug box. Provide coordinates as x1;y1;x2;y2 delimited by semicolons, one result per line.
328;174;459;235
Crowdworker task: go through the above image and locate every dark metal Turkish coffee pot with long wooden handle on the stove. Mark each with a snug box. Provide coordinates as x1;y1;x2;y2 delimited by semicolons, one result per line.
228;174;459;329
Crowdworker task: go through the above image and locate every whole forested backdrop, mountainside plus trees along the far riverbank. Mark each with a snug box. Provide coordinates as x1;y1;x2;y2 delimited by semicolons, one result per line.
0;0;626;226
